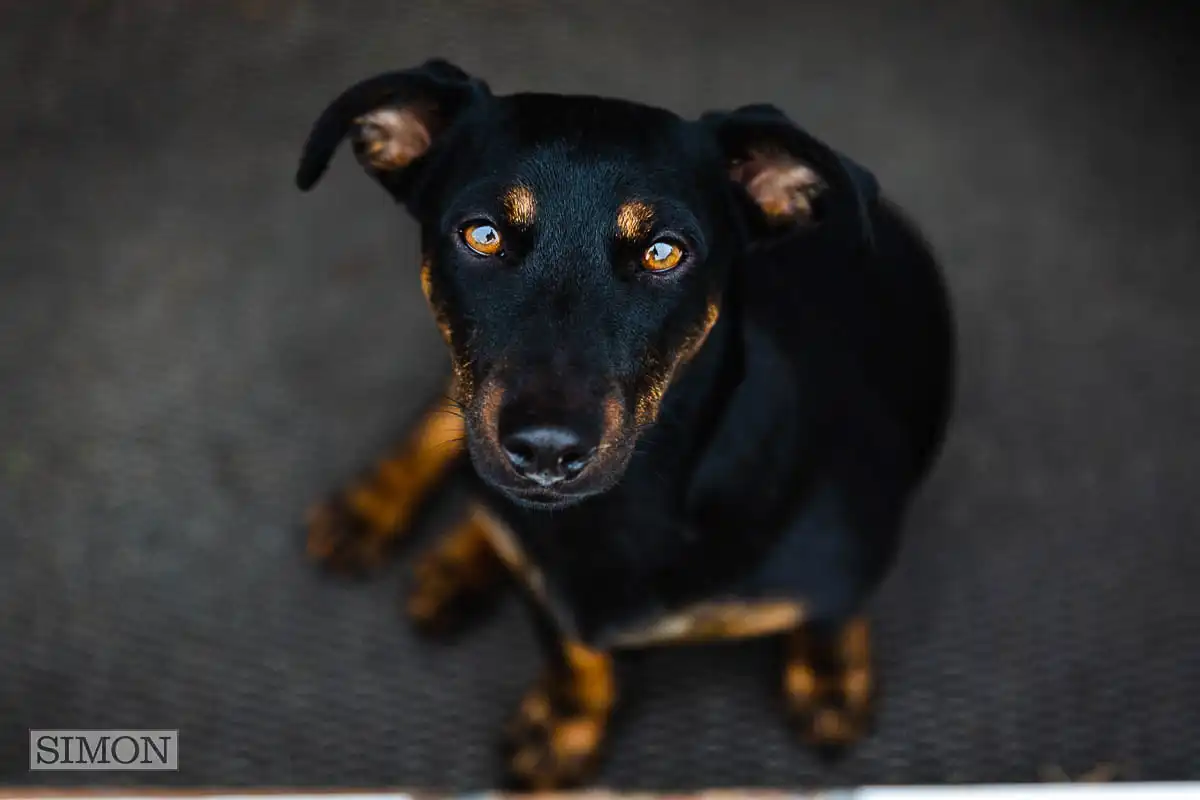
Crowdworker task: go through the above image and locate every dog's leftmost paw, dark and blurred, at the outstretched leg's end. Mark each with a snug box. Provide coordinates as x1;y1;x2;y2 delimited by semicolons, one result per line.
306;495;395;575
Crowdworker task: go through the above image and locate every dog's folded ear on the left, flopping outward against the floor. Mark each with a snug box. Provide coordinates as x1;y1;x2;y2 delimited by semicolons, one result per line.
296;59;491;201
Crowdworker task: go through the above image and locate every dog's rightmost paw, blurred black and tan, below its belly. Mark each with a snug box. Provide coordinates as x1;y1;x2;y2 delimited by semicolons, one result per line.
784;618;876;760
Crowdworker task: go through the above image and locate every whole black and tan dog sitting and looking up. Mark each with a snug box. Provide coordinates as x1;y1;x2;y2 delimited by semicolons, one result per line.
296;60;954;787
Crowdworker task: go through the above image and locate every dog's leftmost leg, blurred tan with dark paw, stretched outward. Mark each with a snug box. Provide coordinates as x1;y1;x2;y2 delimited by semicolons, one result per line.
308;401;464;572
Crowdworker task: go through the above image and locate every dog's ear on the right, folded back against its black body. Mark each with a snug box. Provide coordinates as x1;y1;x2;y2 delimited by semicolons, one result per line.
700;104;878;242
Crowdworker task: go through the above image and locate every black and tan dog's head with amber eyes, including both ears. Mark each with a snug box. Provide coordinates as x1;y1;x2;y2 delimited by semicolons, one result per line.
296;60;860;507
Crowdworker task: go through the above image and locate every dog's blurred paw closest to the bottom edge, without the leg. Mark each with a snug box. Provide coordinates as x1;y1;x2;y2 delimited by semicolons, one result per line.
504;681;608;792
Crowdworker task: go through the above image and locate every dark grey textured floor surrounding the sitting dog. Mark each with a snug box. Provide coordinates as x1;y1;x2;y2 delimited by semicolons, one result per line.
0;0;1200;790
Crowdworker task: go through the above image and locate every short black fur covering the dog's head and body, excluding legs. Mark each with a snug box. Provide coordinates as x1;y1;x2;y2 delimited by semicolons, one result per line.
298;54;954;762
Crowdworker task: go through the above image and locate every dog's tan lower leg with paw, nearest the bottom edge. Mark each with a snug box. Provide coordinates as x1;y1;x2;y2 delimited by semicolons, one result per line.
505;640;617;790
